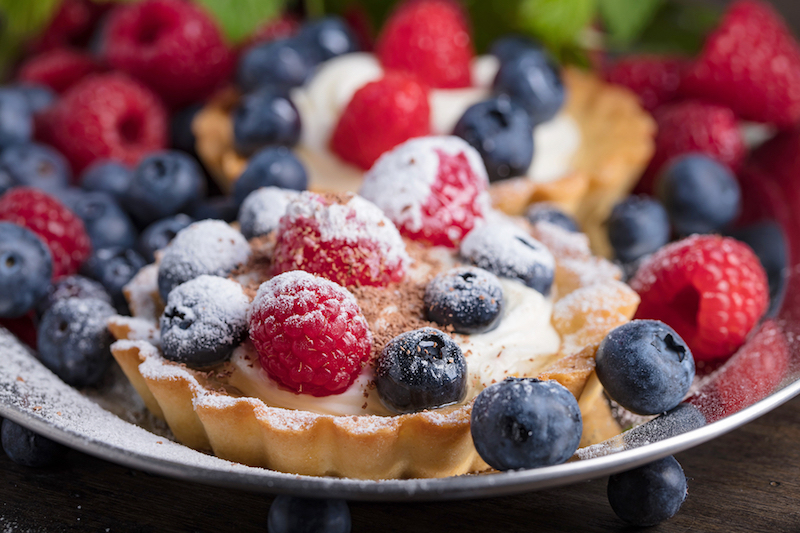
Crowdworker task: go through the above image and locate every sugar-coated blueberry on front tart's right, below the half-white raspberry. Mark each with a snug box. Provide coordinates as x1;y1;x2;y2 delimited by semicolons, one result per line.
461;223;555;296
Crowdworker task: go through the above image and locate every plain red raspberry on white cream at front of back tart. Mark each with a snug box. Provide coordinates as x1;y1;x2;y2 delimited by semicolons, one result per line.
330;71;431;169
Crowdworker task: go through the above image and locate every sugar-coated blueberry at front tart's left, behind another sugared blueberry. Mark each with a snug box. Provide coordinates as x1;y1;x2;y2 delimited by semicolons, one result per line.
158;220;250;302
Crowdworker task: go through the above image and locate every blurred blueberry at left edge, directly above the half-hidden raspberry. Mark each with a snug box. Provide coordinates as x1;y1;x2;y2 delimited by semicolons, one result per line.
0;143;72;194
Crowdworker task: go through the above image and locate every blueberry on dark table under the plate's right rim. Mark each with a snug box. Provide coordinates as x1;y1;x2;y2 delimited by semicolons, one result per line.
608;456;687;527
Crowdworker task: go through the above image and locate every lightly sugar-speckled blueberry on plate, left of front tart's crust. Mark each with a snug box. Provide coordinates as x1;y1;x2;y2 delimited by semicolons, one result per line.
37;298;116;387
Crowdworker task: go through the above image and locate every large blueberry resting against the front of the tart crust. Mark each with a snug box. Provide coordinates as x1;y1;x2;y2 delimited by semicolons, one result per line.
470;378;583;470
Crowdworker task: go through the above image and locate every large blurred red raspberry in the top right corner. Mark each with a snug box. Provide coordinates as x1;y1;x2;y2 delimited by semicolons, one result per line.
681;0;800;126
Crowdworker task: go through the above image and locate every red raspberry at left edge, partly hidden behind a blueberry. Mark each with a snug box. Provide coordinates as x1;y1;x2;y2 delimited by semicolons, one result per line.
0;187;92;279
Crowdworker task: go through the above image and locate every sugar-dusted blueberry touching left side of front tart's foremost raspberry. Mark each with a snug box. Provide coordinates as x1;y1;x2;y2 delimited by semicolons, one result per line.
160;276;250;368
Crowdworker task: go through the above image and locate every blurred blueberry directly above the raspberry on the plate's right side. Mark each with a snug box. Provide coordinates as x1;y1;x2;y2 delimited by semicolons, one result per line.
656;154;741;235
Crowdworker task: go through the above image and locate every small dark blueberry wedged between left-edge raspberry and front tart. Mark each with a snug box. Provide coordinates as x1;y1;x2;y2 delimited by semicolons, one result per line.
81;247;146;314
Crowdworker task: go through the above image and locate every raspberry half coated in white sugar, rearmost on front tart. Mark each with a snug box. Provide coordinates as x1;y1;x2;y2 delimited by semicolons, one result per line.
360;137;489;248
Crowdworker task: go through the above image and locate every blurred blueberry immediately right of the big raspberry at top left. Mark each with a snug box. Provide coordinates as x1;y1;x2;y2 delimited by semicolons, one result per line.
236;38;319;92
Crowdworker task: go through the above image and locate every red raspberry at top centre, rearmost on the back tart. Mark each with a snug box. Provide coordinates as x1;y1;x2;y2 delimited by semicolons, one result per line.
375;0;475;89
